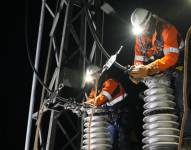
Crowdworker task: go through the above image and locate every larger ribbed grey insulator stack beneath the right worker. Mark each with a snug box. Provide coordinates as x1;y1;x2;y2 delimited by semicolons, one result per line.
142;74;179;150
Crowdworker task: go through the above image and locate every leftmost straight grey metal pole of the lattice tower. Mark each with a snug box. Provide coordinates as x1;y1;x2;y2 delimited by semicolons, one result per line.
25;0;46;150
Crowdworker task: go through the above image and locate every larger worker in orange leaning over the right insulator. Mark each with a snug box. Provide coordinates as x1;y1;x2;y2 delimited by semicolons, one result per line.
130;8;191;145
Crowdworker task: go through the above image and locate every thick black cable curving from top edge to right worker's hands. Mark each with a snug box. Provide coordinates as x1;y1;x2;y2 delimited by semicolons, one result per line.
83;0;126;71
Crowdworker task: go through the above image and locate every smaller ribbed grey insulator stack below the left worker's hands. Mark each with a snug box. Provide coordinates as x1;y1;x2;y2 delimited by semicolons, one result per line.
82;109;112;150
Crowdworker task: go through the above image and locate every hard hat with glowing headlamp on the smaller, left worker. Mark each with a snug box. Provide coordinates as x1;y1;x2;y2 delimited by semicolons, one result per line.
85;65;101;82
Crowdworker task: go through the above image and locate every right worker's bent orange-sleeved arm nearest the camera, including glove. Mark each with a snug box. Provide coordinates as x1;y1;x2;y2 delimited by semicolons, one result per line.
130;26;179;78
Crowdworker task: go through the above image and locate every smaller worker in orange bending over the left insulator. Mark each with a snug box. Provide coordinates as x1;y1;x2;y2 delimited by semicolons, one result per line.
84;65;140;150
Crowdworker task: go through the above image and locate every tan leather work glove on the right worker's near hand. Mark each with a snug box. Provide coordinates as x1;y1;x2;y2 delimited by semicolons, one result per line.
129;63;159;79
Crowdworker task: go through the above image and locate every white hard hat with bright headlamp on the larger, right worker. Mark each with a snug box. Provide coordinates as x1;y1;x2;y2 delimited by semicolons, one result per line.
131;8;152;34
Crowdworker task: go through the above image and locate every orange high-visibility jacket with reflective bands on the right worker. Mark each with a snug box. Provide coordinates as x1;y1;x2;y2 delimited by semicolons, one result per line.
134;23;183;71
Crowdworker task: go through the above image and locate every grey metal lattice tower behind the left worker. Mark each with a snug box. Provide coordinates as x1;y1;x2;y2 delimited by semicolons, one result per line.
25;0;112;150
